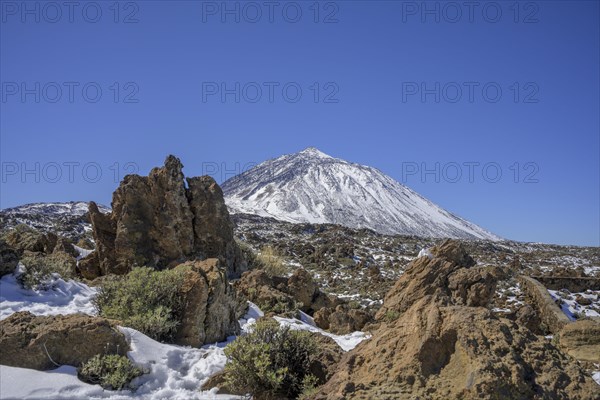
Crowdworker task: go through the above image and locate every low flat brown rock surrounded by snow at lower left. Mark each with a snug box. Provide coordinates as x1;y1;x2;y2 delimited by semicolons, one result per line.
0;311;129;370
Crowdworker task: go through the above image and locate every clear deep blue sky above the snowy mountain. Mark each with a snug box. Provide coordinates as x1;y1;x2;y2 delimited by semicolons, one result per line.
0;0;600;246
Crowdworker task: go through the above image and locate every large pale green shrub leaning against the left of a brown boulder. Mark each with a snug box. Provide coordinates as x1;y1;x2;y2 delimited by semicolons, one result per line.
93;267;185;340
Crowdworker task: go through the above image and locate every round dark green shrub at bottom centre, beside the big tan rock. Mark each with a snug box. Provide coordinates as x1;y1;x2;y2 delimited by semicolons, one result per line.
225;319;316;399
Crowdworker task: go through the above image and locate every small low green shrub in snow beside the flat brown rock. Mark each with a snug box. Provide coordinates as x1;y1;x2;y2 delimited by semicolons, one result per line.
77;354;143;390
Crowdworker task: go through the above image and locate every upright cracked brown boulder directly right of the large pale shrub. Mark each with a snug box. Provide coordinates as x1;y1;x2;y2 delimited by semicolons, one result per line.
175;258;246;347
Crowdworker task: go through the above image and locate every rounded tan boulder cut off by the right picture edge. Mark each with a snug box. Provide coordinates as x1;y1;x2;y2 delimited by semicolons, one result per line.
558;319;600;363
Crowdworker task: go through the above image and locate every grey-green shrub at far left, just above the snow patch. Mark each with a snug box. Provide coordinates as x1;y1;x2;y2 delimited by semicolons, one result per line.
18;252;77;289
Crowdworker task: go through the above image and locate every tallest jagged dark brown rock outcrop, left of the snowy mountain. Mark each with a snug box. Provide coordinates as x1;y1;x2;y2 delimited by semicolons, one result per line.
80;156;246;279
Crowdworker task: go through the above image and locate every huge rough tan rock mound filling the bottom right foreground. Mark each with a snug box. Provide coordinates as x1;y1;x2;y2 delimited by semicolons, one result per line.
311;241;598;399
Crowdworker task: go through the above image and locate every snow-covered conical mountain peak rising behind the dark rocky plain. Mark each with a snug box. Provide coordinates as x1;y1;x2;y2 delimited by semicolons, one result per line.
222;147;500;240
